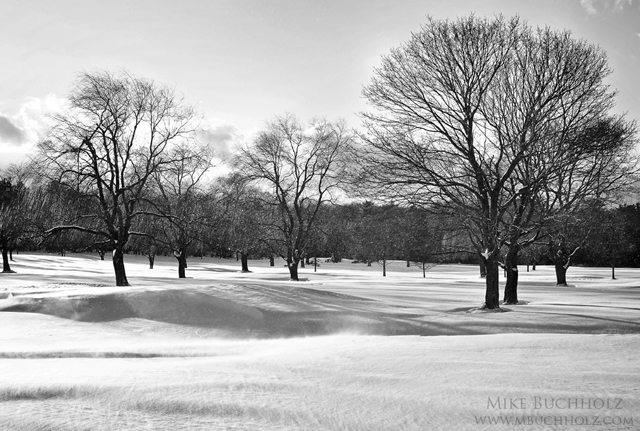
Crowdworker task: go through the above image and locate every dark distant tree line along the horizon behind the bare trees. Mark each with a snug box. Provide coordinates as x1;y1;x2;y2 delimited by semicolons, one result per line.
0;171;640;282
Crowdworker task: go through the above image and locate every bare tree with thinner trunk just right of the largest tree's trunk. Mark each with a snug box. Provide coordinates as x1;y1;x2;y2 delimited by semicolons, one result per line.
490;28;635;304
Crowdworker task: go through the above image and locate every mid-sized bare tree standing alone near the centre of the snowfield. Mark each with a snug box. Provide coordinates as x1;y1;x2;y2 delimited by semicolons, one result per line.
235;115;352;281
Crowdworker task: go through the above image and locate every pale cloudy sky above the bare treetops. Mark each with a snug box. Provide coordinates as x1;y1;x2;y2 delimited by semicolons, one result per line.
0;0;640;165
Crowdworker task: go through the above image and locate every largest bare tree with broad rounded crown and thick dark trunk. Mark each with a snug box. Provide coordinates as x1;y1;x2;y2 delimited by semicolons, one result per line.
363;16;629;309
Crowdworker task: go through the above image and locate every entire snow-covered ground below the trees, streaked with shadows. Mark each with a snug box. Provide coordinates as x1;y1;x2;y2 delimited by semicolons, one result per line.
0;254;640;430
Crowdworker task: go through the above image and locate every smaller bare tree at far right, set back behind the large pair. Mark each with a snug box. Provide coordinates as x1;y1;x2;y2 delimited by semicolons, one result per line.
537;117;638;286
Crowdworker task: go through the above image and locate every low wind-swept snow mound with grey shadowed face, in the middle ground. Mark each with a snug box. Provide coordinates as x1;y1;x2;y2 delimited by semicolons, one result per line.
0;284;470;338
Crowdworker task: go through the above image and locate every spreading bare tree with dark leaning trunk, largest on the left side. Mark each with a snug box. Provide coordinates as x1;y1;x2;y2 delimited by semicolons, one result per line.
34;72;196;286
